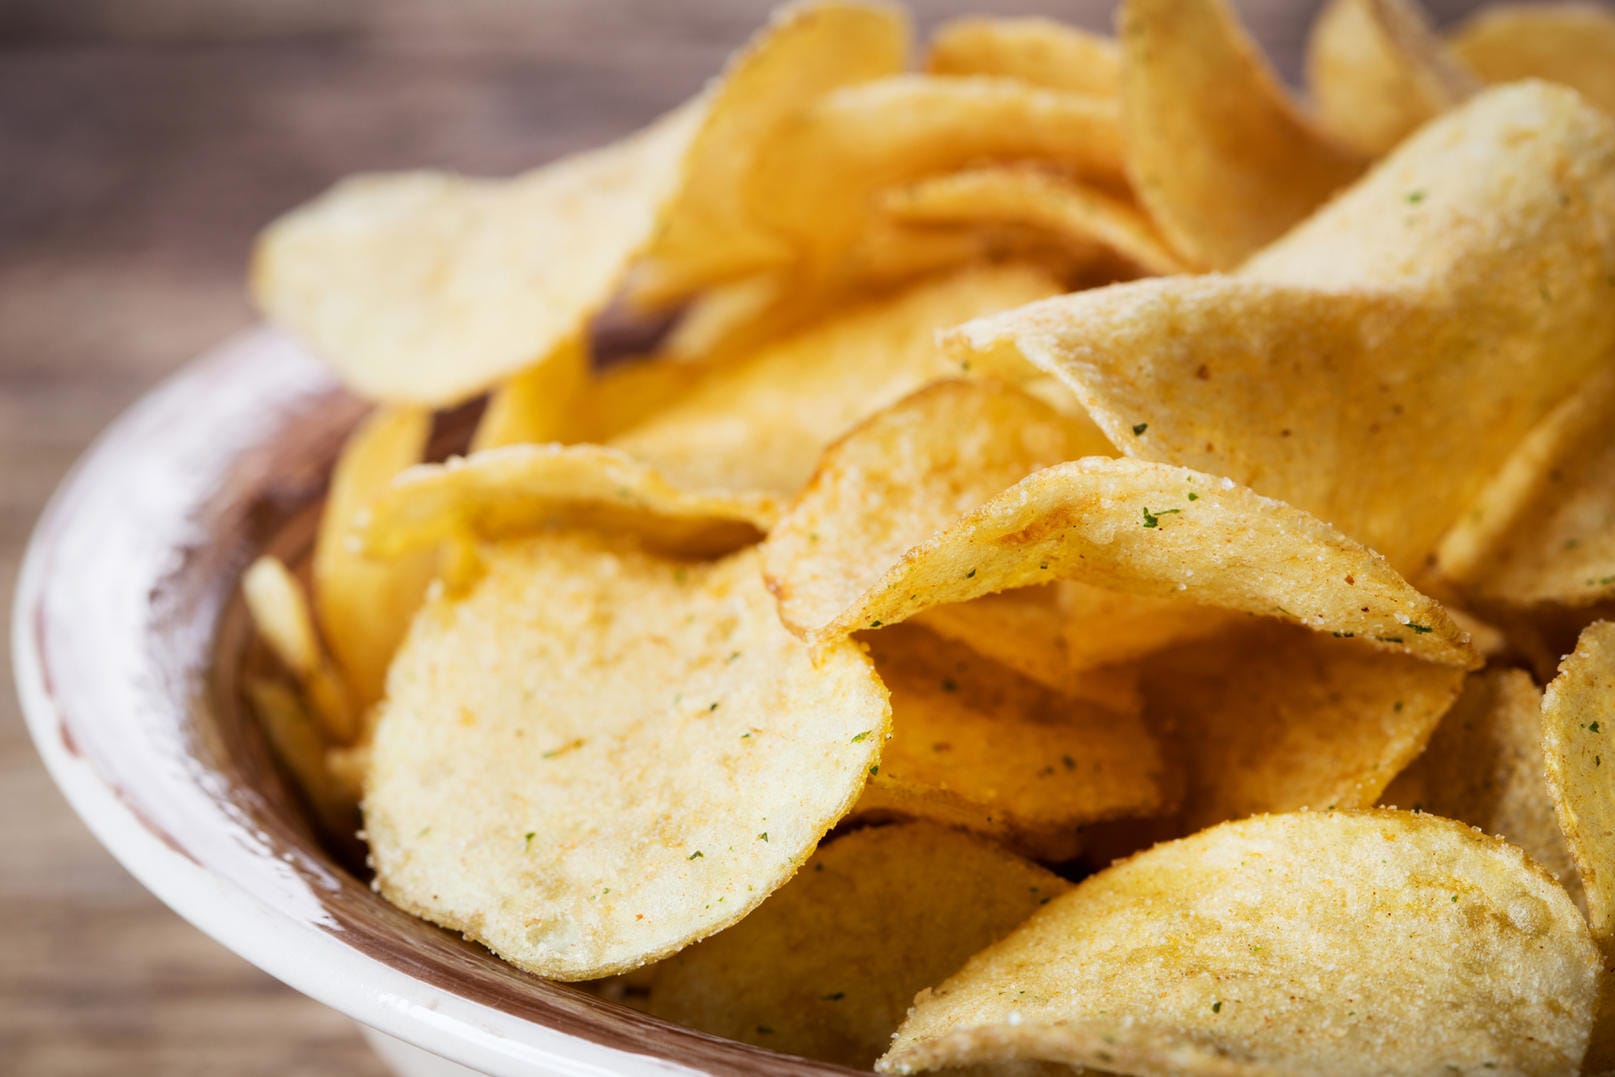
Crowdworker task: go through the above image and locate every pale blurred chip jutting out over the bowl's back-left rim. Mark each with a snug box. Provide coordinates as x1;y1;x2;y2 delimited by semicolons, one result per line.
252;98;707;407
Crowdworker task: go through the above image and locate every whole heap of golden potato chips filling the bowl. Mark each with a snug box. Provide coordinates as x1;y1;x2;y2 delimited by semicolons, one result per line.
244;0;1615;1074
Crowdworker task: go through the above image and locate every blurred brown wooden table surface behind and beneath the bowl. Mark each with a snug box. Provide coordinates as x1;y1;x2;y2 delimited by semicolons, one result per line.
0;0;1471;1075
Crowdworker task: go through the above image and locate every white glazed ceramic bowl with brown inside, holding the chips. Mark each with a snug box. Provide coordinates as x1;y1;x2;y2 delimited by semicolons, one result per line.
13;329;849;1077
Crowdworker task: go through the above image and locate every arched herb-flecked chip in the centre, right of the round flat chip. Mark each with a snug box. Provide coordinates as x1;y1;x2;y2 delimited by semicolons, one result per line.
764;457;1478;665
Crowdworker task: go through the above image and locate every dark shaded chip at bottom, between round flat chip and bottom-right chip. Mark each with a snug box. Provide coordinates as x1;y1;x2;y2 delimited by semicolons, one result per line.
635;823;1071;1069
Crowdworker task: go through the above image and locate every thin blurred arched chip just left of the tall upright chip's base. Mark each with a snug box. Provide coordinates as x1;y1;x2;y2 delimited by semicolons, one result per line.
880;166;1187;276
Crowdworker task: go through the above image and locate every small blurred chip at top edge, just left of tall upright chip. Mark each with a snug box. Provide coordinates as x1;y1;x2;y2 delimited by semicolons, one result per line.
925;16;1121;97
